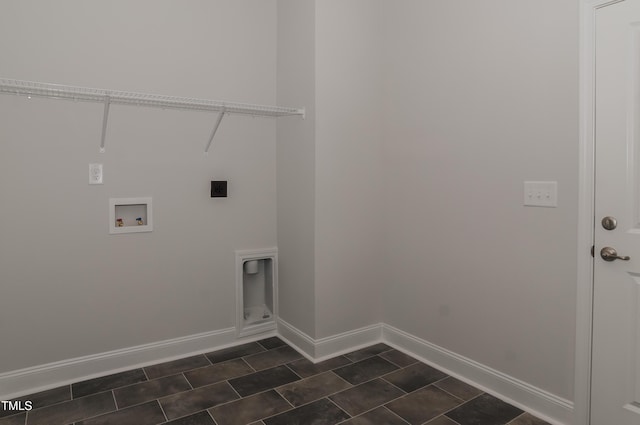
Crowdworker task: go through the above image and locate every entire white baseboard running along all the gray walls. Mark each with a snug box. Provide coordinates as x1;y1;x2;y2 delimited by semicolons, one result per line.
0;319;574;425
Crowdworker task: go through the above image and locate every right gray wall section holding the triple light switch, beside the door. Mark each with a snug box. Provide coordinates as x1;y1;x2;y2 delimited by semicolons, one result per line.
382;0;579;399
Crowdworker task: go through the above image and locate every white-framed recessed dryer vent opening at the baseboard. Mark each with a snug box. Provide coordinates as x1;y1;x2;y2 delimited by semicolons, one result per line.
236;248;277;336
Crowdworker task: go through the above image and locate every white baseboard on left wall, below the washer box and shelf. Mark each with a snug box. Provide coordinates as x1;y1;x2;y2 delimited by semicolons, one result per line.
0;328;245;400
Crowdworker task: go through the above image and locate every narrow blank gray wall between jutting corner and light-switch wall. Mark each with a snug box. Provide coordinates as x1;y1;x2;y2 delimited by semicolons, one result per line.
316;0;386;337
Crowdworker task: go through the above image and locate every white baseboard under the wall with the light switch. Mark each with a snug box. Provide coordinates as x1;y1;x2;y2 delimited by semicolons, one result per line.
382;324;573;425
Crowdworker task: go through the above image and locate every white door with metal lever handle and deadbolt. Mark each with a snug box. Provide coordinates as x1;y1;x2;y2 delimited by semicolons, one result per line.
591;0;640;425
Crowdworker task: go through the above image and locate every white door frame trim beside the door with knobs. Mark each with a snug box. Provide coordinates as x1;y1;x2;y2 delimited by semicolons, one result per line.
573;0;625;425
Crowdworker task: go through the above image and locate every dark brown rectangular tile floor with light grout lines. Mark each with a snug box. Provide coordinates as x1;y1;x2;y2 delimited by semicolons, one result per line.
0;337;548;425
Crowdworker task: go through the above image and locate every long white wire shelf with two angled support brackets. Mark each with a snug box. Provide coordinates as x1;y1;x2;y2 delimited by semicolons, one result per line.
0;78;305;152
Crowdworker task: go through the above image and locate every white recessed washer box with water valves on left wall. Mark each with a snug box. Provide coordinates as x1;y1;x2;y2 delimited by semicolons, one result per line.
109;198;153;235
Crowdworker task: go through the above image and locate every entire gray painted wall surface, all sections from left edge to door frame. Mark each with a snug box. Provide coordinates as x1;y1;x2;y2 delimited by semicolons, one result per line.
0;0;578;399
